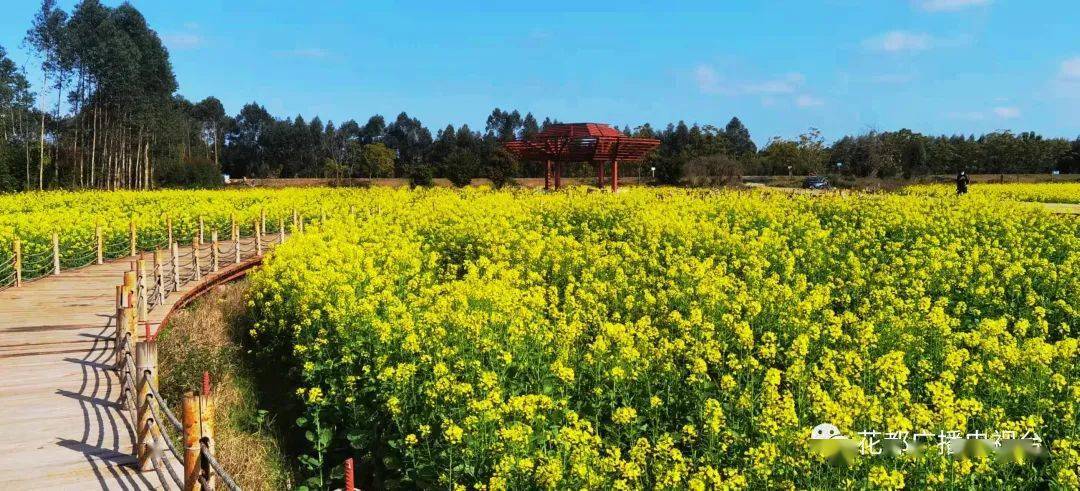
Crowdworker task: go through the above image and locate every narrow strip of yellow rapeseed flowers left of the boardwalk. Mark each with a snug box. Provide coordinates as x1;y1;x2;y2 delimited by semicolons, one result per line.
0;188;368;280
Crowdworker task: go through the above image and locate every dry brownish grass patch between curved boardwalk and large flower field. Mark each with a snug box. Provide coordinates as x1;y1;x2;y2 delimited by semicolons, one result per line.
158;281;295;490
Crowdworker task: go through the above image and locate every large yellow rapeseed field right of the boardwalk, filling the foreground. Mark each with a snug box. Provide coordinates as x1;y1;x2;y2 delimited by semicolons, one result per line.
251;186;1080;490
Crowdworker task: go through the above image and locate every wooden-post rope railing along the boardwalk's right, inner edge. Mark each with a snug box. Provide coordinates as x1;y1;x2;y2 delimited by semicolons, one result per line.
97;212;302;491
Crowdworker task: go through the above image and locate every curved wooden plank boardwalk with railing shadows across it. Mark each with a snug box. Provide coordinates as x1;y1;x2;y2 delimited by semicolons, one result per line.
0;242;258;490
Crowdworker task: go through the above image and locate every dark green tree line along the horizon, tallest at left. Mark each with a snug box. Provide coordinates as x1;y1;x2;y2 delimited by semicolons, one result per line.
0;0;1080;191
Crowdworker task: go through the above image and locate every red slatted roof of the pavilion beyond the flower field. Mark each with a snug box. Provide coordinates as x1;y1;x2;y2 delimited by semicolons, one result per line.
504;123;660;162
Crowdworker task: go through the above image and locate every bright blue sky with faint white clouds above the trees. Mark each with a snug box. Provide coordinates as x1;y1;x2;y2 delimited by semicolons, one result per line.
0;0;1080;144
